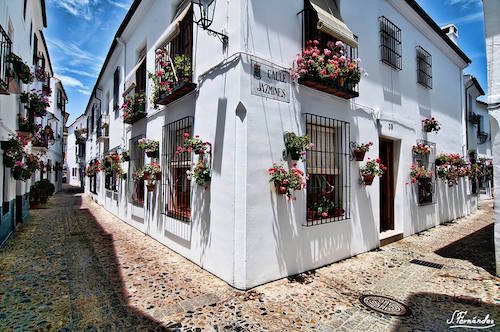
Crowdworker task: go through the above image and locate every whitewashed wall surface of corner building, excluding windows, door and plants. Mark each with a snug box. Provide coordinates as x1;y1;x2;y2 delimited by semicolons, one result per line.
76;0;477;289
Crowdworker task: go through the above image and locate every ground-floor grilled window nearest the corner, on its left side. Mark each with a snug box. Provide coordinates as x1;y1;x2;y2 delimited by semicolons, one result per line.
162;116;193;221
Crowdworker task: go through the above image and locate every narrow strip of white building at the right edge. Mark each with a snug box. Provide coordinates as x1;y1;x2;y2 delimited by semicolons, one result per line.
483;0;500;275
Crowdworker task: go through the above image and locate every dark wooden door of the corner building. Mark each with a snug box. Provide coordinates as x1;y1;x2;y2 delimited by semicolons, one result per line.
380;139;394;232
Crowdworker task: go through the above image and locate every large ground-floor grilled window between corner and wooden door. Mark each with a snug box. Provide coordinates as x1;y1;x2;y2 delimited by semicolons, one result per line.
305;114;351;226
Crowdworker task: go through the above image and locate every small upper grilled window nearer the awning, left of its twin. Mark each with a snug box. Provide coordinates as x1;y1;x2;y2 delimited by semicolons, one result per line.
379;16;403;70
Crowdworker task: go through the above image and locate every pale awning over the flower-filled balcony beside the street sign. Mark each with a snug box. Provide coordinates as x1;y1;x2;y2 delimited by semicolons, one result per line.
309;0;358;47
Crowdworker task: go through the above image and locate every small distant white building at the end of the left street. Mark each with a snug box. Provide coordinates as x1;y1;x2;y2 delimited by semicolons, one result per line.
65;114;87;188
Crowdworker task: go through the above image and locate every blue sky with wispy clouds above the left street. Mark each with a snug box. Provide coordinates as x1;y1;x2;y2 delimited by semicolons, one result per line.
44;0;133;124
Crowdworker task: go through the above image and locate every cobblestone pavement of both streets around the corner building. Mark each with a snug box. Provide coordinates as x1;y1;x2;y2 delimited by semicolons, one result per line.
0;189;500;331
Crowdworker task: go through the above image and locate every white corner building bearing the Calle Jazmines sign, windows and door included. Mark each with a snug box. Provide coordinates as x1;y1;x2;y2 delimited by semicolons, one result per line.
72;0;477;289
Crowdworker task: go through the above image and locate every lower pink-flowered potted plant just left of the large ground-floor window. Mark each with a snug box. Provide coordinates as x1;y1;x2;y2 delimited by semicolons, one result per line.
268;162;308;199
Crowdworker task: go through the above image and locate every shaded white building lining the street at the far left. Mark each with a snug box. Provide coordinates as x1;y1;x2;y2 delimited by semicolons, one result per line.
0;0;67;243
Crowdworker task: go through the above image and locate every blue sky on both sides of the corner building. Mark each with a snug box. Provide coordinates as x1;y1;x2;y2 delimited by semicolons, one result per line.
45;0;486;123
